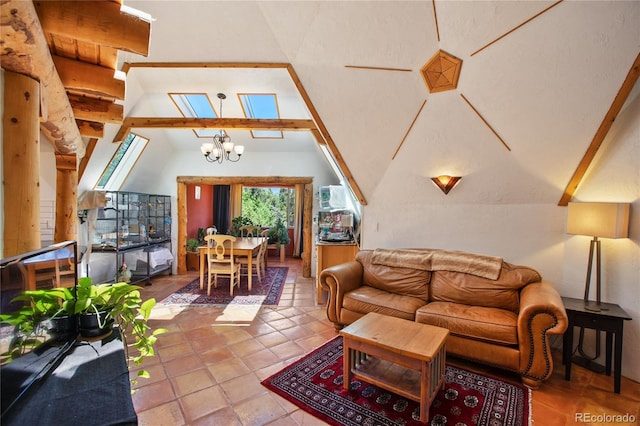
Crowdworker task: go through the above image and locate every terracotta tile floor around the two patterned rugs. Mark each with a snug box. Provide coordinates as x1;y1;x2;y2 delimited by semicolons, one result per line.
132;259;640;426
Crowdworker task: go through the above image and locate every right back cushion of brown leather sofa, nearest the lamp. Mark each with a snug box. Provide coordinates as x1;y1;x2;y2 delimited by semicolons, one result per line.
430;262;540;312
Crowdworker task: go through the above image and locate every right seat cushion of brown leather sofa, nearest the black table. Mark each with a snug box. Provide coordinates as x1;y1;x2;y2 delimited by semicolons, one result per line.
415;302;518;345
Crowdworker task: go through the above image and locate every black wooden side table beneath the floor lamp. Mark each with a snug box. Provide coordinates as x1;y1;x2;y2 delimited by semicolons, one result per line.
562;297;631;393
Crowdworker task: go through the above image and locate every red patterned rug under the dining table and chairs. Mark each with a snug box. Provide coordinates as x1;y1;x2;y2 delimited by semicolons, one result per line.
160;266;289;305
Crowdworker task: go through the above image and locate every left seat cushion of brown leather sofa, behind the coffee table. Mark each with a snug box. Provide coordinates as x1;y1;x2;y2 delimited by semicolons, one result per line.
342;286;426;321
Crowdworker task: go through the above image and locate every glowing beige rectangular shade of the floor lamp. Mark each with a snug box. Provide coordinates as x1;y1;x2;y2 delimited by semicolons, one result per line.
567;203;630;238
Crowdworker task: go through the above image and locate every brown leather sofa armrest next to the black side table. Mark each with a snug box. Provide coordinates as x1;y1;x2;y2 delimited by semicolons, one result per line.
518;281;569;388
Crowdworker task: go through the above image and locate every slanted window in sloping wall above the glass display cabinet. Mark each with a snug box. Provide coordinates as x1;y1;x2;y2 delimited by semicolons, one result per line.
95;133;149;191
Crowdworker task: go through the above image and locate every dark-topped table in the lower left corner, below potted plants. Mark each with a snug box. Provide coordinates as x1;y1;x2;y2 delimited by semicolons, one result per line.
0;330;138;426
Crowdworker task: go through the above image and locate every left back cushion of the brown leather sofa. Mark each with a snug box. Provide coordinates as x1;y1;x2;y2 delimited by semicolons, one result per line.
356;250;431;303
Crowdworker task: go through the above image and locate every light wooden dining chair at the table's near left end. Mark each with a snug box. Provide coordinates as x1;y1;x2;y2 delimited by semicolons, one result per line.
204;234;240;296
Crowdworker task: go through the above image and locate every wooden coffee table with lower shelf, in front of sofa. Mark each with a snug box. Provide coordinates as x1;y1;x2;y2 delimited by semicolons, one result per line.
340;313;449;422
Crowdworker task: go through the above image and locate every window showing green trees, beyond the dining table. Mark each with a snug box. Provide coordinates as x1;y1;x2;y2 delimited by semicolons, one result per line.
242;187;296;227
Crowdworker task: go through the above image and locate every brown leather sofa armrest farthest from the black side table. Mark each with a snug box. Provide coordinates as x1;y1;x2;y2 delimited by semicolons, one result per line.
320;260;364;327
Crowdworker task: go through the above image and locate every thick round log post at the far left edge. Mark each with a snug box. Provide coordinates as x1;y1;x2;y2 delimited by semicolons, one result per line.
2;71;41;257
